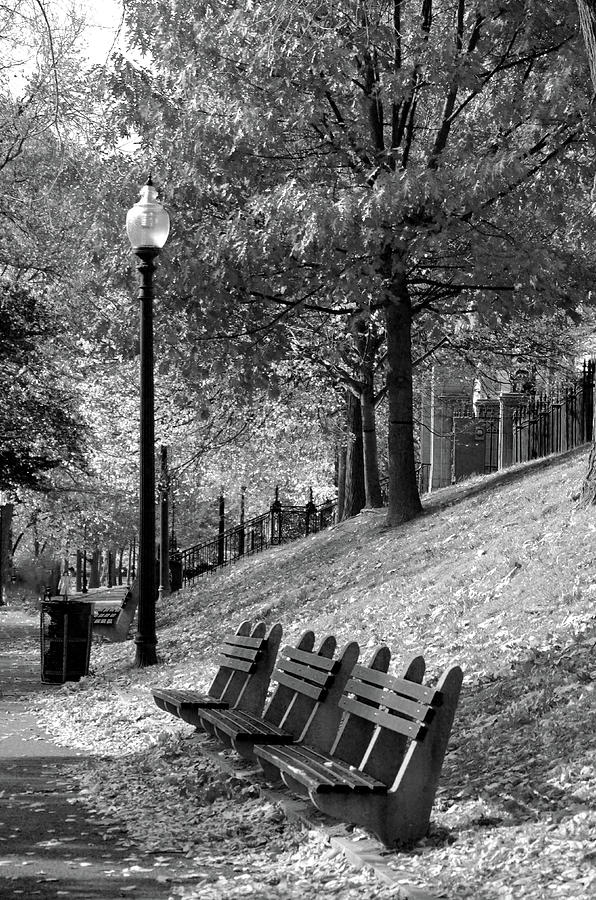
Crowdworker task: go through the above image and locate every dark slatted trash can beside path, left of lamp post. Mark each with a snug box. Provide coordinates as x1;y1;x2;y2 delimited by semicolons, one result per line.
40;597;93;684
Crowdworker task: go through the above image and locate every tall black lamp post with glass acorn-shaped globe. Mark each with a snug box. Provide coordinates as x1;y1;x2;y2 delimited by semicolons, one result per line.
126;178;170;668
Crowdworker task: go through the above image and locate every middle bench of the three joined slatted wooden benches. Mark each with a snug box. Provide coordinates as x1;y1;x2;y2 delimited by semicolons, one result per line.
193;631;424;759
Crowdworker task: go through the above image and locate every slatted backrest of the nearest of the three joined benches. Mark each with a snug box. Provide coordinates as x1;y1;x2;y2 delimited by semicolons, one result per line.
331;665;442;784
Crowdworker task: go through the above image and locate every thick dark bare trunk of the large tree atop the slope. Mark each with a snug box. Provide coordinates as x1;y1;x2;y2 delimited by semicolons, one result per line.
385;274;422;525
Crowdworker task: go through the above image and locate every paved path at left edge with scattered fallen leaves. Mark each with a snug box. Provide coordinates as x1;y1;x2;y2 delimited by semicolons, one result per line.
0;607;171;900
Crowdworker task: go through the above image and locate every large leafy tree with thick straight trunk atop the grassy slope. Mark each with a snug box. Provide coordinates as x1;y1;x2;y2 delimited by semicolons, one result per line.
110;0;587;524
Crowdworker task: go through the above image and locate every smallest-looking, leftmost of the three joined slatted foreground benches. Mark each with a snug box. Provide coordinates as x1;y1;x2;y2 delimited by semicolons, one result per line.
151;622;282;729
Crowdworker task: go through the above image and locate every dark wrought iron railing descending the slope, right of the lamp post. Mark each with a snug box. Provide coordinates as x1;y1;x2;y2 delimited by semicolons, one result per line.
170;500;336;590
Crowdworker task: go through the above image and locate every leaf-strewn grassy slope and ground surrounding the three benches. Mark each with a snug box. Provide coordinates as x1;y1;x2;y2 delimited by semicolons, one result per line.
25;452;596;900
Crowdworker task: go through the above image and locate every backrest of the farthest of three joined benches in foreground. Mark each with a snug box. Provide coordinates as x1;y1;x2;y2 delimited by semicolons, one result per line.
208;622;281;714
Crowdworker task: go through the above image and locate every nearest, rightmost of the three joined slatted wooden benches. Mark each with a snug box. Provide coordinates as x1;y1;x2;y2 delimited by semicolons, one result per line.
255;651;462;847
